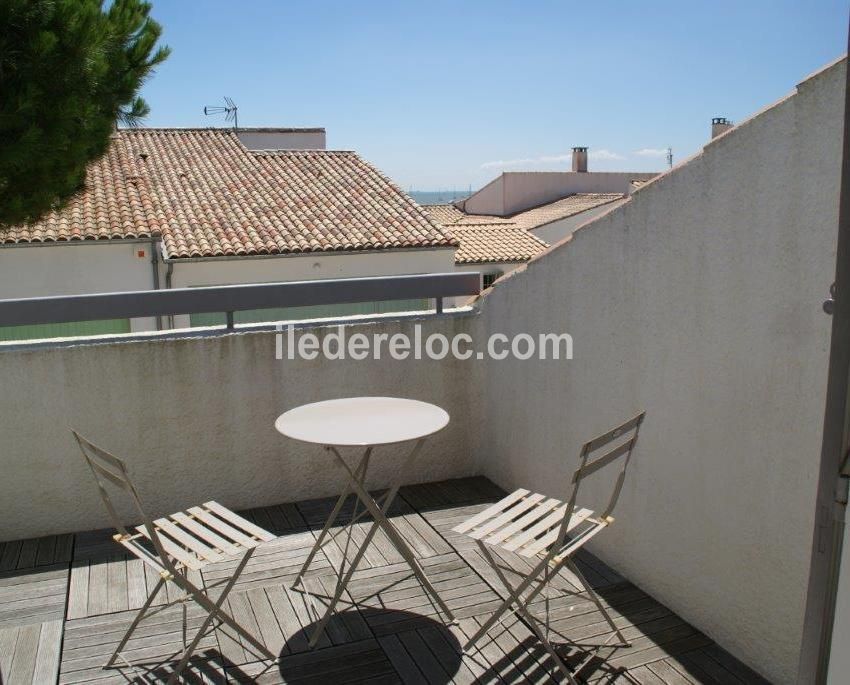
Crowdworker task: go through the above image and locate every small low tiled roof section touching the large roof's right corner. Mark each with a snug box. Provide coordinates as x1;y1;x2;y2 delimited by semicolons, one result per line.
452;224;549;264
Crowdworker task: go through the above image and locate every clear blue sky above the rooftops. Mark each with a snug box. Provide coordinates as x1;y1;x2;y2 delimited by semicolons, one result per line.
143;0;848;190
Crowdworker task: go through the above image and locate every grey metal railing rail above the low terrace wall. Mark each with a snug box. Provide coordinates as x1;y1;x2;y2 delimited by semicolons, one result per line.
0;272;481;328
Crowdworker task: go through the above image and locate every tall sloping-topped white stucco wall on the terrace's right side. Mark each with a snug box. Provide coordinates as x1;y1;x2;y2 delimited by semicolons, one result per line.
468;56;846;683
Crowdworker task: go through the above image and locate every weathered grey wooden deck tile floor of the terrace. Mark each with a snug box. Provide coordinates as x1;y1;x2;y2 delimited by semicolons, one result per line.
0;478;765;685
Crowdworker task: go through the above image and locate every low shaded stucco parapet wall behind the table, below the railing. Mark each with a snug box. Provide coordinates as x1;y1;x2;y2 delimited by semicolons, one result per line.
0;315;474;540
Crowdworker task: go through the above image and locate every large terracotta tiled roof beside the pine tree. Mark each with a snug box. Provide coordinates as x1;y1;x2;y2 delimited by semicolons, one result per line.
0;129;457;258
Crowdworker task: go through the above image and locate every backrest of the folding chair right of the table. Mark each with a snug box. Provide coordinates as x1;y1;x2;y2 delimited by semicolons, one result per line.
558;411;646;544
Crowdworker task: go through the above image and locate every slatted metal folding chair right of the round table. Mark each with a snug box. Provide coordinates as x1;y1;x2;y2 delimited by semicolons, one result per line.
454;412;645;683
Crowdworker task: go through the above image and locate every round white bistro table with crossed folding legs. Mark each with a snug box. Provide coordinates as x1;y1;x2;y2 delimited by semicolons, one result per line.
274;397;455;647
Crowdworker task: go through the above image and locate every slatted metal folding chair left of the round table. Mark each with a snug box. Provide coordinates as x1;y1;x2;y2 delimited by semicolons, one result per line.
71;431;276;683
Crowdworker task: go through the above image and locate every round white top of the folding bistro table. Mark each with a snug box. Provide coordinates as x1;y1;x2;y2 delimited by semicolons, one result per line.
274;397;449;447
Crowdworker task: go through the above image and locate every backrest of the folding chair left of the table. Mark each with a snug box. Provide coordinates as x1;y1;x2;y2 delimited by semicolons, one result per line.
71;429;174;572
